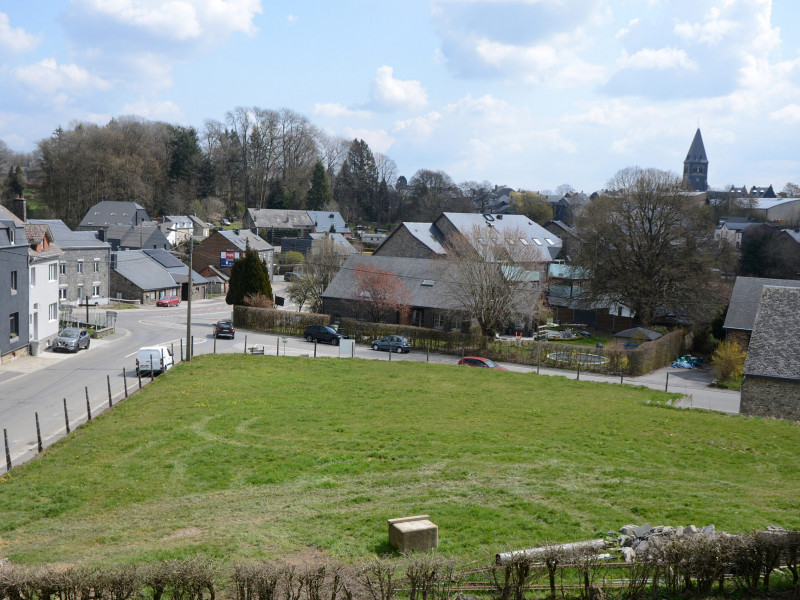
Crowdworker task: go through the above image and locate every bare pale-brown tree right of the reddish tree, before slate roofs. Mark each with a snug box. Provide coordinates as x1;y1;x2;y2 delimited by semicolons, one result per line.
443;227;544;344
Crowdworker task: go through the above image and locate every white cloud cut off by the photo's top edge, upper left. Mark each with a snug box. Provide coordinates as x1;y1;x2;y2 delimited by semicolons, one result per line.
74;0;262;41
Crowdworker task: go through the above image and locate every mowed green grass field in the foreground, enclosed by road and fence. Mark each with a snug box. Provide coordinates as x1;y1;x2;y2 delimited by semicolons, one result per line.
0;355;800;564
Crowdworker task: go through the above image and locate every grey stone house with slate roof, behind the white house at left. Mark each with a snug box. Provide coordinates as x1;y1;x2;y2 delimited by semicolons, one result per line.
28;219;111;305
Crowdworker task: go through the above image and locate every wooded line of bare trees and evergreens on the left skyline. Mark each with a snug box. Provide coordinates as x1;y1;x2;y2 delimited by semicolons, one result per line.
0;106;512;226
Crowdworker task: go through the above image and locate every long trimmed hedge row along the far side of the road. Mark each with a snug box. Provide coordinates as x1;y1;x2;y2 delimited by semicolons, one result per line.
233;306;686;377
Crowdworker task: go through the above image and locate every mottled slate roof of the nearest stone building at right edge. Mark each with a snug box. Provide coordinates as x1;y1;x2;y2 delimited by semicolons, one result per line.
744;285;800;381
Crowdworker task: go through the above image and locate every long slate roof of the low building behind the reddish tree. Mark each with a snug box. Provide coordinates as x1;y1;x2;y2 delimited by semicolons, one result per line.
322;254;460;310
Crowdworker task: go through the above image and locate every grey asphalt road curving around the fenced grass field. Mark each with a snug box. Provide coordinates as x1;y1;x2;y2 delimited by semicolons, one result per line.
0;298;739;472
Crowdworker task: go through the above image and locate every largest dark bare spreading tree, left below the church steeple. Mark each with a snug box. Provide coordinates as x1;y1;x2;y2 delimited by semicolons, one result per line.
575;167;713;325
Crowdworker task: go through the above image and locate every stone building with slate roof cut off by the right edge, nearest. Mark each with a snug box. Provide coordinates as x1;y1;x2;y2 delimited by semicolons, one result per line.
739;285;800;421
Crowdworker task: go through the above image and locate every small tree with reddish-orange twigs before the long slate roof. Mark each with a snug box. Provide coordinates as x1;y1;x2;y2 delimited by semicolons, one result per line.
353;264;411;323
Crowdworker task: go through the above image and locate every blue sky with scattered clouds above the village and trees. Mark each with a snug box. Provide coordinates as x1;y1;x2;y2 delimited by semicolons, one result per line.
0;0;800;192
